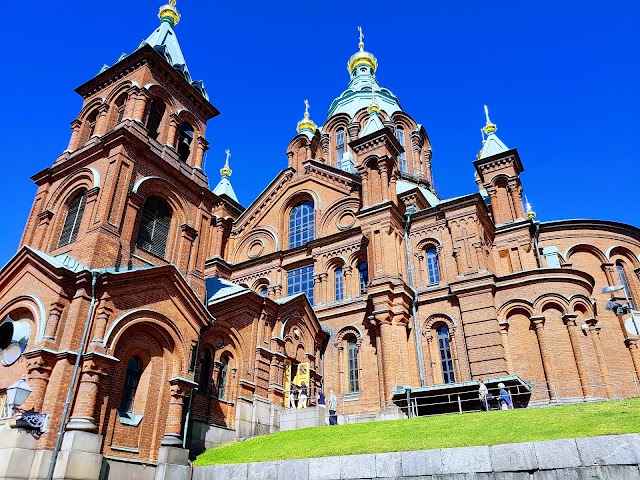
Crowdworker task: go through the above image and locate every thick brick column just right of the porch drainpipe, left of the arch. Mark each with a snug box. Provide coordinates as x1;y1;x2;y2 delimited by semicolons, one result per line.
65;355;106;433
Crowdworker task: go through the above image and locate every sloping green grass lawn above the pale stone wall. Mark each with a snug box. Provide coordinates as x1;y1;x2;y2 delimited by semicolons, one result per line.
195;399;640;465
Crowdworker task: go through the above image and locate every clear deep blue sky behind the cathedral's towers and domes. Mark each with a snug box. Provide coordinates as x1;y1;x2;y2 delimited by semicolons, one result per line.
0;0;640;263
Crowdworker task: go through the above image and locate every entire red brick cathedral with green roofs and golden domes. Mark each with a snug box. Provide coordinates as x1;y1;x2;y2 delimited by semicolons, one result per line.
0;0;640;479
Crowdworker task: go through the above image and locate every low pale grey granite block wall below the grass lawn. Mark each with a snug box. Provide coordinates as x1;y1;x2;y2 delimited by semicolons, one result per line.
193;434;640;480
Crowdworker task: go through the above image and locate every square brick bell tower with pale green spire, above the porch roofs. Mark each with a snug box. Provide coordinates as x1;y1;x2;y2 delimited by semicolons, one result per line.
21;0;224;296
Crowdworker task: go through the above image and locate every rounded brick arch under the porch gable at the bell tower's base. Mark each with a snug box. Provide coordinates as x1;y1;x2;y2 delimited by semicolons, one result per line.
102;309;190;376
